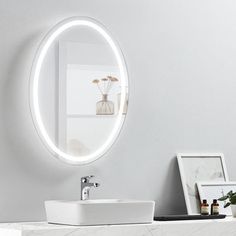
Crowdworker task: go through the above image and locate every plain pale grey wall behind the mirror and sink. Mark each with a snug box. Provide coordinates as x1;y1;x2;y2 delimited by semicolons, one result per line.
0;0;236;222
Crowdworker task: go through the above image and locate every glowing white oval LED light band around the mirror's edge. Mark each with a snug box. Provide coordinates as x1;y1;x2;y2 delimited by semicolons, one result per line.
31;17;128;164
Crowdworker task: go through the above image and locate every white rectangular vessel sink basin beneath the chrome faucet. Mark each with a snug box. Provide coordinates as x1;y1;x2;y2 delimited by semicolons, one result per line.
45;199;155;225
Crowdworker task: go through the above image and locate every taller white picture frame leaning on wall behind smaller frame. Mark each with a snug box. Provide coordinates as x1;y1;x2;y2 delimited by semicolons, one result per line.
177;153;229;215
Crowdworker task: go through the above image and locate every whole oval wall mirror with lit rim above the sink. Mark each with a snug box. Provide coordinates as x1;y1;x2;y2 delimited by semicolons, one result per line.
30;17;128;164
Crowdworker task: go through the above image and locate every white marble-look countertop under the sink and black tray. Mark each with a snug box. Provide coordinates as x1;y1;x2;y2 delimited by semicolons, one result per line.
0;217;236;236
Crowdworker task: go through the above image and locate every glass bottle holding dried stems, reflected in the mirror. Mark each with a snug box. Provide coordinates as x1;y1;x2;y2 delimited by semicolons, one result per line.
96;94;114;115
